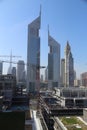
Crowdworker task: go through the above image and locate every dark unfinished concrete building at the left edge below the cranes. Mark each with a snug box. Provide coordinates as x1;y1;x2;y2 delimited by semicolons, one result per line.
0;74;16;103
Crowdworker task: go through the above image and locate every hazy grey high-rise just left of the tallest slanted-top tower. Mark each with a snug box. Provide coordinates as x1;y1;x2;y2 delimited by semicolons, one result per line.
17;60;25;82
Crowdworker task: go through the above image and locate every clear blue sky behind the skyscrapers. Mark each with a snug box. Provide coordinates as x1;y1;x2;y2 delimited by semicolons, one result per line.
0;0;87;76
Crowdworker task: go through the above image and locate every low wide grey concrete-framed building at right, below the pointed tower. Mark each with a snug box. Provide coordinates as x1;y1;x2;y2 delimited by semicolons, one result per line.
55;87;87;108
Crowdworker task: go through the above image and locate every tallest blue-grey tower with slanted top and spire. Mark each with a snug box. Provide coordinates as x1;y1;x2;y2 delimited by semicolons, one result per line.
27;11;41;93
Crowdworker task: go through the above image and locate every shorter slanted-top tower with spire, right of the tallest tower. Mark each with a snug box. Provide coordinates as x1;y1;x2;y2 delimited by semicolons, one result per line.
48;31;60;88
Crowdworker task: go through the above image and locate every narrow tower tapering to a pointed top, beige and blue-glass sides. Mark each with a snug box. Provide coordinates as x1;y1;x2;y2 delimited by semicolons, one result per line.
65;41;74;87
